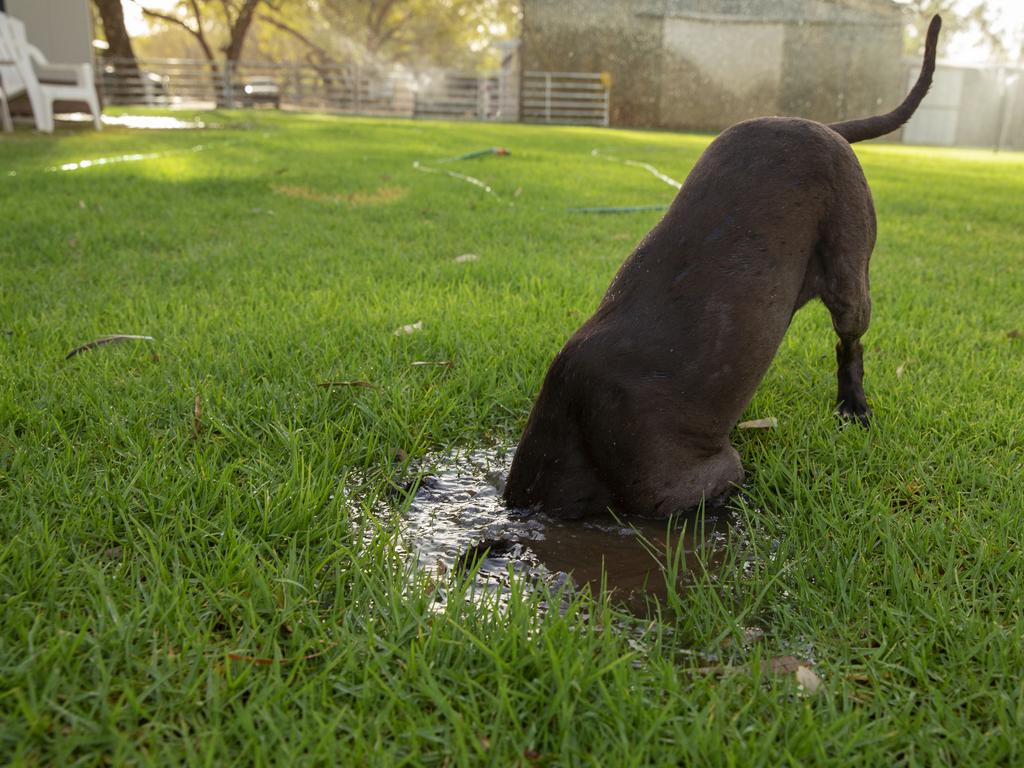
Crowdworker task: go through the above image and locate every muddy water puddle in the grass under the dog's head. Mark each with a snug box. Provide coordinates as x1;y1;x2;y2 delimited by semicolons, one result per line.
400;450;736;614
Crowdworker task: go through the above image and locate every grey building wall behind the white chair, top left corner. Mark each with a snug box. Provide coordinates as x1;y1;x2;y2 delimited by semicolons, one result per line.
4;0;92;63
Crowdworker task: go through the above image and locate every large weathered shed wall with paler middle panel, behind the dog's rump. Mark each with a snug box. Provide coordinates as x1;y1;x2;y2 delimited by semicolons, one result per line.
522;0;903;130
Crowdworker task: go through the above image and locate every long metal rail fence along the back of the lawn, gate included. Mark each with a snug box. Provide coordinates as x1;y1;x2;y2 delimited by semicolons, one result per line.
97;58;608;125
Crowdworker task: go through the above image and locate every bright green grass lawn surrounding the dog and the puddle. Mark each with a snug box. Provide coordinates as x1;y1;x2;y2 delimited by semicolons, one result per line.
0;112;1024;766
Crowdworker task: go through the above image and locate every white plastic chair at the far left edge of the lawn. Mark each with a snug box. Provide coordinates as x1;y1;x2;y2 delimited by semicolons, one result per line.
0;12;102;133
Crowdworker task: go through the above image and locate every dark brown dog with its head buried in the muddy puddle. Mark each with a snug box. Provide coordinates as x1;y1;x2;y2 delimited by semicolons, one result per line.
505;16;941;517
